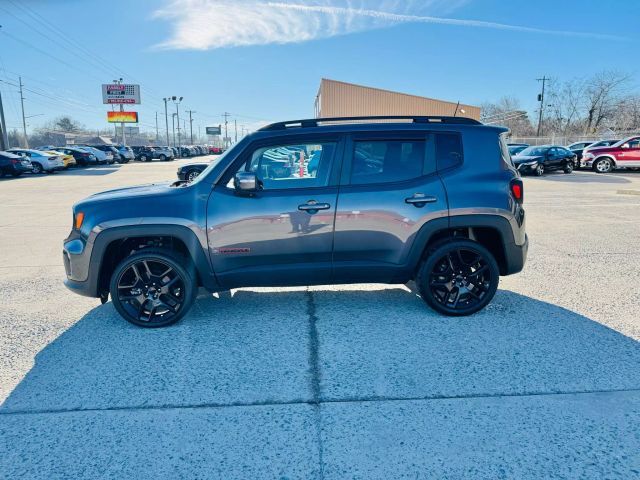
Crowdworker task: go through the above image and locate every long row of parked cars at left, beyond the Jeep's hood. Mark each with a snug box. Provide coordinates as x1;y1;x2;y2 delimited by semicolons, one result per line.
0;145;222;177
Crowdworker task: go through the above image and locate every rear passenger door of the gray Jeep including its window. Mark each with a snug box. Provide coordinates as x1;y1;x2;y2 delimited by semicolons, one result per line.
333;131;448;283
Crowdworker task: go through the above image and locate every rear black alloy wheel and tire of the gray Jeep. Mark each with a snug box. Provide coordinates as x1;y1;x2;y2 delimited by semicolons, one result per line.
416;239;500;316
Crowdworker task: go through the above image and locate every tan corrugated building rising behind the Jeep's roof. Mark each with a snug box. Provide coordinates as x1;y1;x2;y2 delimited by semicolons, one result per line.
315;78;480;120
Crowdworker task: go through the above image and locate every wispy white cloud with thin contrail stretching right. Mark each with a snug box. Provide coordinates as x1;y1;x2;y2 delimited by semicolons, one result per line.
154;0;619;50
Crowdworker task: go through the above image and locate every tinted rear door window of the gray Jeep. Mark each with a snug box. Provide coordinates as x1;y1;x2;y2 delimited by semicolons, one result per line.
351;139;435;185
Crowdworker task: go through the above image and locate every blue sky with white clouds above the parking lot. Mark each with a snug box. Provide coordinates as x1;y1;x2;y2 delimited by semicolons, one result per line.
0;0;640;135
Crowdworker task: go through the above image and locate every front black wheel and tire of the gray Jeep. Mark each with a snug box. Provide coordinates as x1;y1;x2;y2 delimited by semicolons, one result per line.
109;249;198;328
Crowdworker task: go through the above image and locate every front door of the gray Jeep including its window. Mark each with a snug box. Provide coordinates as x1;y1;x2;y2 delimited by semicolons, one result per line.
207;136;341;288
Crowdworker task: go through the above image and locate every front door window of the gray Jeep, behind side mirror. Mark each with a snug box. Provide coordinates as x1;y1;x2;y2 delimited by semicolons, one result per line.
227;142;337;190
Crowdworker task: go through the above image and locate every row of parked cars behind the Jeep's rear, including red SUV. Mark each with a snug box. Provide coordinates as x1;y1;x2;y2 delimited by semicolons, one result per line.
508;136;640;176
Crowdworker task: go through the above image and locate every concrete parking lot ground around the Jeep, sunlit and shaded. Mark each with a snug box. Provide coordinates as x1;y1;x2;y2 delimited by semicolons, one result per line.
0;161;640;479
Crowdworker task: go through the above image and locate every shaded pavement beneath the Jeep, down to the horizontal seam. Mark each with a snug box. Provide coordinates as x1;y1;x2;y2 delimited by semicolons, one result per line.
0;286;640;413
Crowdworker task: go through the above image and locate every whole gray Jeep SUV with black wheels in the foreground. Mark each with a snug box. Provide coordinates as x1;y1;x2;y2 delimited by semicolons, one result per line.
63;117;528;327
